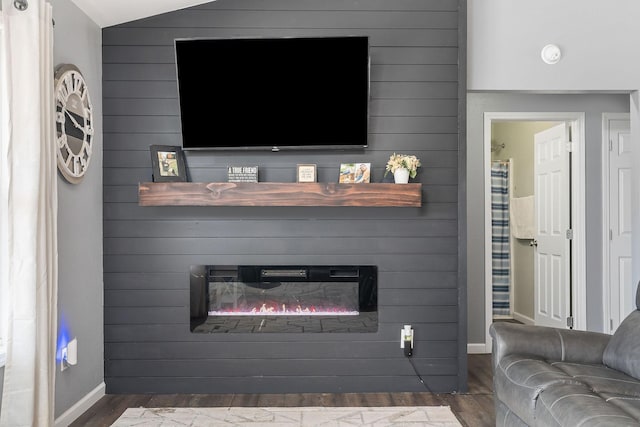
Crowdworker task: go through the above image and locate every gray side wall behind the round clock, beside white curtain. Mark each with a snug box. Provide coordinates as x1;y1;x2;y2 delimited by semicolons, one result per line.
52;0;104;417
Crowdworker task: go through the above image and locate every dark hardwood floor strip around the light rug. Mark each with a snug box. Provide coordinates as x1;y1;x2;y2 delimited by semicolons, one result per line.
71;354;495;427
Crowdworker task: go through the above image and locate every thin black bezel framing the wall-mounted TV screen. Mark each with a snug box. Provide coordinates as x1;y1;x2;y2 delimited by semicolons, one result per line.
173;35;371;152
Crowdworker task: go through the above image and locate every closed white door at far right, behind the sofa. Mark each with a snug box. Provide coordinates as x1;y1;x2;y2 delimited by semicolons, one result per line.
605;120;635;333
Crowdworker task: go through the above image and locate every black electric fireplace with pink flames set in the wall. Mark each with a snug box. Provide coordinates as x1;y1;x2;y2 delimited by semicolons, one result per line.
190;265;378;333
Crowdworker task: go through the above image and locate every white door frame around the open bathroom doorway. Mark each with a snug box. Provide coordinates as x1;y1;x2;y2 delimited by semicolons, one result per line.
483;112;587;353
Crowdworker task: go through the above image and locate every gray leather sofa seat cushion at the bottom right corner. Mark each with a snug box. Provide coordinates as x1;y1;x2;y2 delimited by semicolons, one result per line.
531;384;640;427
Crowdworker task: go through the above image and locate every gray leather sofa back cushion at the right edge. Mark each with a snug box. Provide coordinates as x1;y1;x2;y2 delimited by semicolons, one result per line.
602;310;640;378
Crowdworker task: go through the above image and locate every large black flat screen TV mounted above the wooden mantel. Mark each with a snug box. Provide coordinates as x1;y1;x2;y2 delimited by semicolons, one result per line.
175;36;369;151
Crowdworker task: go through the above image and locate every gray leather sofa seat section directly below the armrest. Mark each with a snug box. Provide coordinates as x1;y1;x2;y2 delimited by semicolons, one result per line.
494;354;581;425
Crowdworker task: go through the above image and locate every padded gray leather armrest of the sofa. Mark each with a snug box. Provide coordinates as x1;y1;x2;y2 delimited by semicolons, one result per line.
490;322;611;367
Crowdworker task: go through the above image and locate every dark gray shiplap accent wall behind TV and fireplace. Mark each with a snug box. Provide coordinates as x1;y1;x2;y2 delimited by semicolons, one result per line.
103;0;466;393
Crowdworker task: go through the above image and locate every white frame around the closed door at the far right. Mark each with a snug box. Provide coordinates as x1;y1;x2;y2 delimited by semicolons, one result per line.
601;113;631;333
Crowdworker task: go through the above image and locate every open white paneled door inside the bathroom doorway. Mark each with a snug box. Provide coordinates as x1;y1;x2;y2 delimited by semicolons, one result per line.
534;123;571;328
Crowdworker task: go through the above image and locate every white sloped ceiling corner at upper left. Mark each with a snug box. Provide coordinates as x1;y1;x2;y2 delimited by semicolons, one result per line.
71;0;211;28
